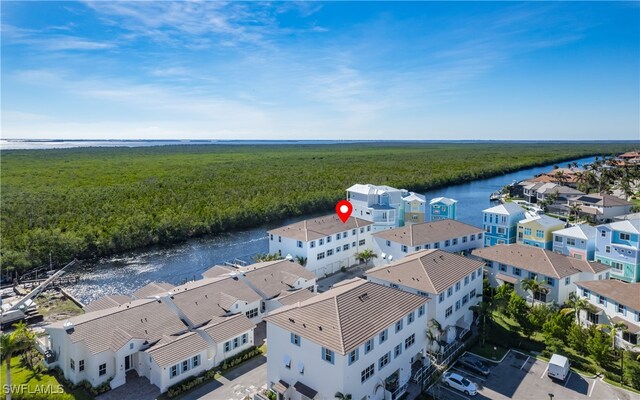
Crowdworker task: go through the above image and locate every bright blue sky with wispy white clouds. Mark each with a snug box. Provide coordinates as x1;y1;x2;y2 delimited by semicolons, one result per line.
1;1;640;140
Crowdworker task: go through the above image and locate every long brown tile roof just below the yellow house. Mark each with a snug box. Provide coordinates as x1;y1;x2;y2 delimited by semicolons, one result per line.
472;244;609;278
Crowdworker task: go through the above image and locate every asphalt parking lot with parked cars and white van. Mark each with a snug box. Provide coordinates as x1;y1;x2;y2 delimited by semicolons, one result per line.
429;351;640;400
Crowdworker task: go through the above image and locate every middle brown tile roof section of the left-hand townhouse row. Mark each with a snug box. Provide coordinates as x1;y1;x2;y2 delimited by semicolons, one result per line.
171;277;262;326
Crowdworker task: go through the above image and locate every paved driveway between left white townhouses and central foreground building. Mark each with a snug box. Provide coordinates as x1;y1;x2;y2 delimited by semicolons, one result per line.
180;356;267;400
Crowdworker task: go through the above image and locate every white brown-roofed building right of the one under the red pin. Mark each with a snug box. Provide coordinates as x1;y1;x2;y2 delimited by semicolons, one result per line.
373;219;483;265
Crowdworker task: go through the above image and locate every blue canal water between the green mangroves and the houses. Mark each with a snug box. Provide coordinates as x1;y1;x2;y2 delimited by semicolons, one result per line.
67;157;594;304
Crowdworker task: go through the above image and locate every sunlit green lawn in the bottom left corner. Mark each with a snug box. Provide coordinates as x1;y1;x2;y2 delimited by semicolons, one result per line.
0;356;92;400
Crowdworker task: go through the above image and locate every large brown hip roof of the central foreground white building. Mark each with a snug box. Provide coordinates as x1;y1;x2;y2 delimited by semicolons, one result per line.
265;278;429;355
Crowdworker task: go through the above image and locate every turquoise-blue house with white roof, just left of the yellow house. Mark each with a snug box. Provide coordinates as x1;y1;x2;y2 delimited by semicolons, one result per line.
482;203;525;247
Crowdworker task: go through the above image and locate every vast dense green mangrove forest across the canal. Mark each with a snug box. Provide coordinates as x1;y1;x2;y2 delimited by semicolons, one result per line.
0;143;637;271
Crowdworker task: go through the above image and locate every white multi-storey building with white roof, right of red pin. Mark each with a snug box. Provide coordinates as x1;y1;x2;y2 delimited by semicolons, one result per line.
347;184;406;232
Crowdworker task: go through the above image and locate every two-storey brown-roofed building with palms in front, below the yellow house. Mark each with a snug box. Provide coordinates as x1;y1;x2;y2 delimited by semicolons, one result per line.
472;244;610;304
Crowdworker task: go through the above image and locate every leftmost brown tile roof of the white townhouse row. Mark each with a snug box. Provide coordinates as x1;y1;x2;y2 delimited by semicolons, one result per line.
48;299;187;354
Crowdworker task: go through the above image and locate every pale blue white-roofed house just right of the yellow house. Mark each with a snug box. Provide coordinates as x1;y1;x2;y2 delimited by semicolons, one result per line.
553;224;596;261
